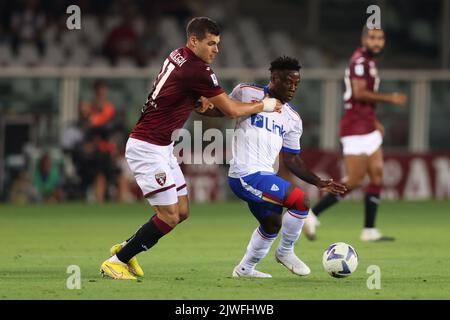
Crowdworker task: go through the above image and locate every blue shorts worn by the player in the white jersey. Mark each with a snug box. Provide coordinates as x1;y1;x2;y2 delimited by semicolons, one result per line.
228;172;291;221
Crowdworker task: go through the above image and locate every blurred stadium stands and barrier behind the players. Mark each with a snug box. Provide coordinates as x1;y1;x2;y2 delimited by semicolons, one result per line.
0;0;450;203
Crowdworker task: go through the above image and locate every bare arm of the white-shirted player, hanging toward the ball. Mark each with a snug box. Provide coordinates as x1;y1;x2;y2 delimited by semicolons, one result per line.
282;152;347;194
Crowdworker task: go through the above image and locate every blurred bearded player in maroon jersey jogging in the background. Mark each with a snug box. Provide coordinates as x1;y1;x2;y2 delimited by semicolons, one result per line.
304;26;407;241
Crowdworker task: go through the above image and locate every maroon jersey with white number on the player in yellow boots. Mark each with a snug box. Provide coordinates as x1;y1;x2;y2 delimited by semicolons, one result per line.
130;47;224;146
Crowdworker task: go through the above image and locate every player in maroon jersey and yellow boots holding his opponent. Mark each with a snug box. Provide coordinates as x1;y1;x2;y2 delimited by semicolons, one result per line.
100;17;281;280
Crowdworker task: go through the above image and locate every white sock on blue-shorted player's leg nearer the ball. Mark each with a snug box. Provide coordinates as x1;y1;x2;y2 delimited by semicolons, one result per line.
277;210;308;255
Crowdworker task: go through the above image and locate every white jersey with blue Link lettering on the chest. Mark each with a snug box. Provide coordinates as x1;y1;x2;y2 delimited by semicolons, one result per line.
228;84;303;178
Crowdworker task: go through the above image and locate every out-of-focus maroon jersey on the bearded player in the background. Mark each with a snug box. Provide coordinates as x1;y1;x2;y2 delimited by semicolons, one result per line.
341;48;380;137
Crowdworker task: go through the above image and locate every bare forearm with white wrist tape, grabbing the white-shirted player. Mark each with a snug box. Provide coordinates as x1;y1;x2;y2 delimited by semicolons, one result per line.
208;93;281;119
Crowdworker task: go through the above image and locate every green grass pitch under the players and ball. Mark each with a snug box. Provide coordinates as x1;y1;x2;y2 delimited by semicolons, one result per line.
0;201;450;300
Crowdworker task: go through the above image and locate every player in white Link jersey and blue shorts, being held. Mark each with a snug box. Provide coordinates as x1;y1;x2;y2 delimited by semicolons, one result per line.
199;57;346;278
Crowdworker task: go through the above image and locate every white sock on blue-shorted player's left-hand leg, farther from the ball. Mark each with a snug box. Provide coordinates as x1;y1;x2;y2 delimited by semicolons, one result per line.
239;226;277;273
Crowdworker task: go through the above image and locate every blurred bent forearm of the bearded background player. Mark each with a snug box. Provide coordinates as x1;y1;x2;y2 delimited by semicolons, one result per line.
351;79;407;106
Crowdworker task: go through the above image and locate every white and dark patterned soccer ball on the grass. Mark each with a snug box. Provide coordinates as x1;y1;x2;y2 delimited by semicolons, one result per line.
322;242;358;278
